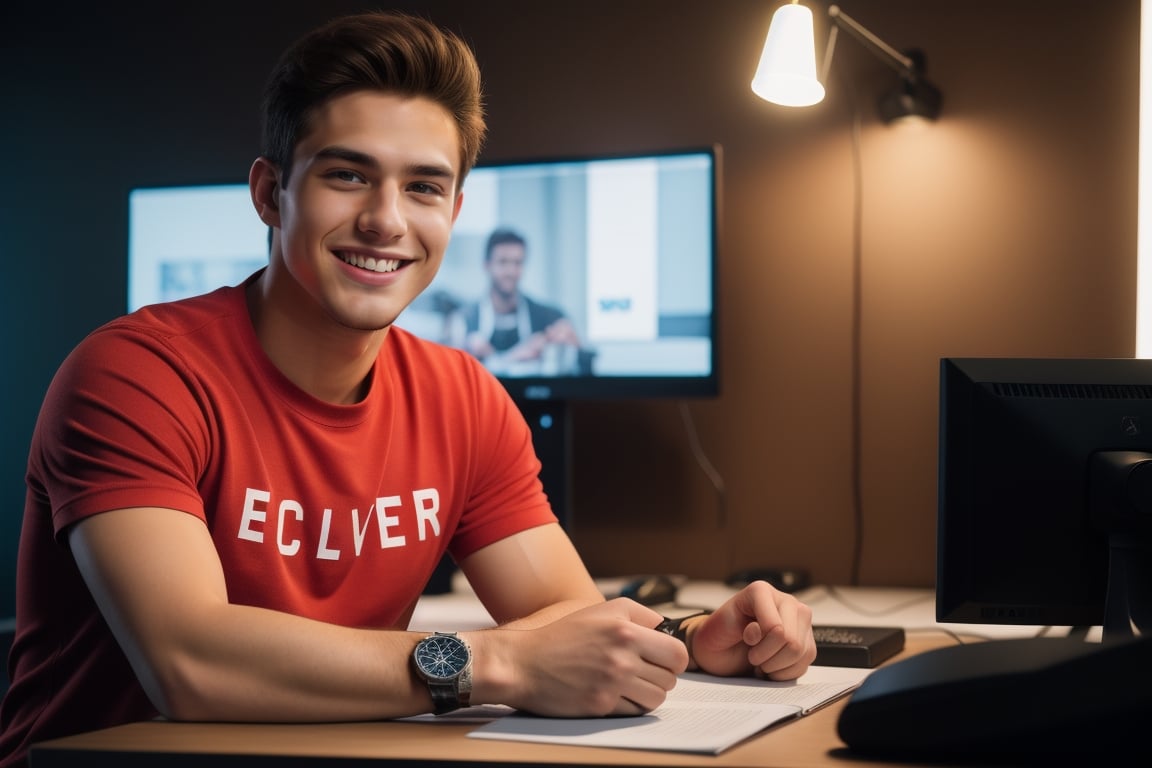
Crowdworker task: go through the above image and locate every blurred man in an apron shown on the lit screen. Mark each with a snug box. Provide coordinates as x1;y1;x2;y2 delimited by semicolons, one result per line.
463;229;589;375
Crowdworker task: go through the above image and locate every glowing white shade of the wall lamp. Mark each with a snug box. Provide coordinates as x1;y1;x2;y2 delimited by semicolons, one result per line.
752;3;824;107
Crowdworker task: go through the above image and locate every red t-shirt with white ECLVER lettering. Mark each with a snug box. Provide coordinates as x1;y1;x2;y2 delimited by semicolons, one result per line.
0;280;556;767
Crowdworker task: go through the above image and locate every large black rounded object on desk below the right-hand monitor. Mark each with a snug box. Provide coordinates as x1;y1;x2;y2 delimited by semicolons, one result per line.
838;638;1152;765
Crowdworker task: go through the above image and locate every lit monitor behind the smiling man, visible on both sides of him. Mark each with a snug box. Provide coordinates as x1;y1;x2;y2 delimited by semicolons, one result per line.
128;146;720;523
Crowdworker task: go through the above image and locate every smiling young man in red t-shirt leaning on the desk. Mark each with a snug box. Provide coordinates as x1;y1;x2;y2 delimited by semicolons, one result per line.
0;14;814;768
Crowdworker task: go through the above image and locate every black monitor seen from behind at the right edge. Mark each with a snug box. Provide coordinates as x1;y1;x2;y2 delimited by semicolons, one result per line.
935;358;1152;639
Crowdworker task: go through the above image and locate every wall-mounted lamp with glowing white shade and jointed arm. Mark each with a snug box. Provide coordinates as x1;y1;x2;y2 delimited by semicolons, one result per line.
752;0;940;123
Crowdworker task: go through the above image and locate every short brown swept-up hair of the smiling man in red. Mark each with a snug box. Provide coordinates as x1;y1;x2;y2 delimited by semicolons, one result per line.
262;13;487;185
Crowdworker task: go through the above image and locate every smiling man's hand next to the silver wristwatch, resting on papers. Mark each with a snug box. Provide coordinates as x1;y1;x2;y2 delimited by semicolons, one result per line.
468;599;688;717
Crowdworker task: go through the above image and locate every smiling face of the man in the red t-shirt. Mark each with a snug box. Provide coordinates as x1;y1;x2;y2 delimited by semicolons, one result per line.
273;91;462;330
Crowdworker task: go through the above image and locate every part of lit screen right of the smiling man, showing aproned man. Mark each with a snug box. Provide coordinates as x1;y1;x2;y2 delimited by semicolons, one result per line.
397;149;718;400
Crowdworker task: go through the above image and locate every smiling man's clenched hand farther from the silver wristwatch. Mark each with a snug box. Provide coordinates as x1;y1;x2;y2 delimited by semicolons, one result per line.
688;581;816;680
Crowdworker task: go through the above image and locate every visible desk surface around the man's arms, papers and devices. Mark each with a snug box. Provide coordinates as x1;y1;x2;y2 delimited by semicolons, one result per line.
31;581;1069;768
